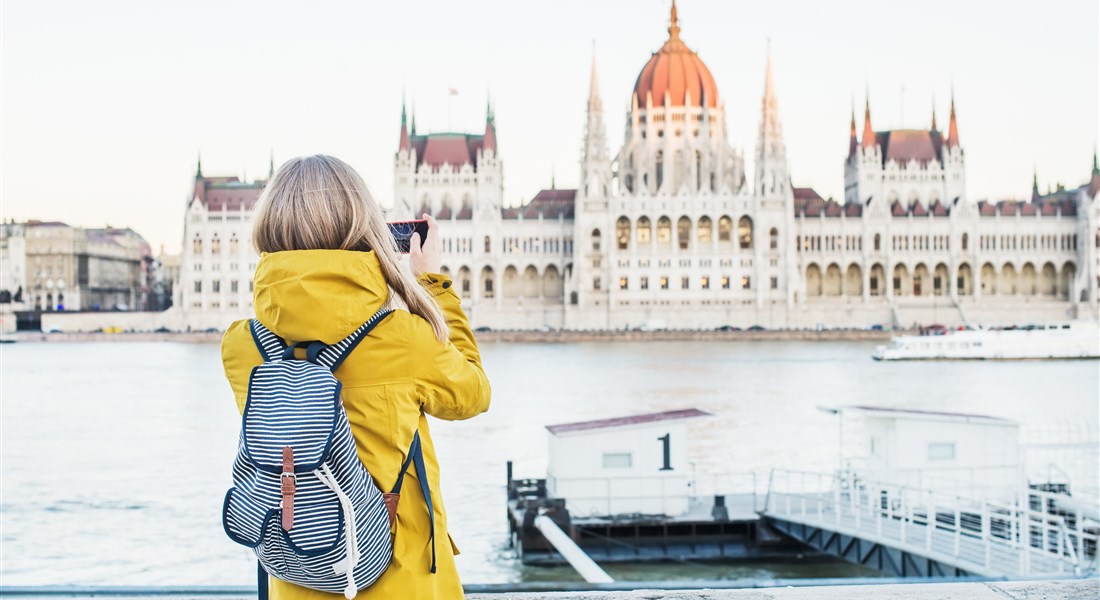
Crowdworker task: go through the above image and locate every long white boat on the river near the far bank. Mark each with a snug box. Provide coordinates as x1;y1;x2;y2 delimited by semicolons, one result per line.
871;321;1100;360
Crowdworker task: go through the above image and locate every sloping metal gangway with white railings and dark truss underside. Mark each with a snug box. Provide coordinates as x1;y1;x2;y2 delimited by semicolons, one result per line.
761;470;1100;578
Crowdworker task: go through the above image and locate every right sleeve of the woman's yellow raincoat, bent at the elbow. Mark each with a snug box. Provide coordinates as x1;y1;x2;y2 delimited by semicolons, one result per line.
411;273;490;421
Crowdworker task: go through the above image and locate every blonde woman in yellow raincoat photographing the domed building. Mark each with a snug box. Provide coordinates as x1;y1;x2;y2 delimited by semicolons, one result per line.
222;155;490;600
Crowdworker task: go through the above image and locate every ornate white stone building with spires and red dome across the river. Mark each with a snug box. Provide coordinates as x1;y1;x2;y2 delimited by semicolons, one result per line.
176;4;1100;329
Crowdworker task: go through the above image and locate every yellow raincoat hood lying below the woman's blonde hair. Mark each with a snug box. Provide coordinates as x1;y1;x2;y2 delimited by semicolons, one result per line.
253;250;389;345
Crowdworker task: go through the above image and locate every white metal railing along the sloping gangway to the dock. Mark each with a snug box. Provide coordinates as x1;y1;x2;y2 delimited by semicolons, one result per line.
765;470;1097;576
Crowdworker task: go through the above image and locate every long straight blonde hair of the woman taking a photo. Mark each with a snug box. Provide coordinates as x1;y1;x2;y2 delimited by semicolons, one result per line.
252;154;449;341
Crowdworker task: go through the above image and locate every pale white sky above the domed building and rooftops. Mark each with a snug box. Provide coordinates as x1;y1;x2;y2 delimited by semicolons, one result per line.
0;0;1100;252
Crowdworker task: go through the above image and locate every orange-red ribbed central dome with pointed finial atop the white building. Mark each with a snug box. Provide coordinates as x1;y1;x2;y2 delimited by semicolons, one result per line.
634;0;718;108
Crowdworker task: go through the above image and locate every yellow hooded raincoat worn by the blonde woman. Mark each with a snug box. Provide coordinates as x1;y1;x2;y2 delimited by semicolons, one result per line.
221;250;490;600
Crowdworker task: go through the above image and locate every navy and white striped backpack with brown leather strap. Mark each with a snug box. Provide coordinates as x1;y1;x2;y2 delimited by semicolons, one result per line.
222;309;436;600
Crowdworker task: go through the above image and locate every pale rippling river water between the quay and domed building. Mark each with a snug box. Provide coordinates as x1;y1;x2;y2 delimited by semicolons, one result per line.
0;341;1100;586
